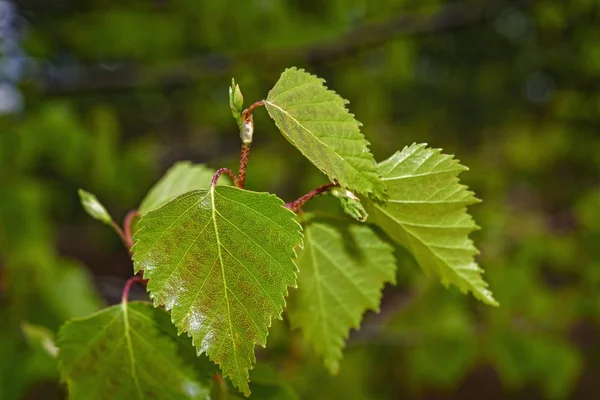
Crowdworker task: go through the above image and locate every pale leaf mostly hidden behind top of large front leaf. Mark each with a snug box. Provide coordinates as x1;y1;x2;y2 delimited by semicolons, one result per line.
139;161;231;215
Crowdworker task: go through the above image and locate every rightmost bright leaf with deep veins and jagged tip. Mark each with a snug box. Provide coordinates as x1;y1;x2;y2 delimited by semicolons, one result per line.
368;144;498;305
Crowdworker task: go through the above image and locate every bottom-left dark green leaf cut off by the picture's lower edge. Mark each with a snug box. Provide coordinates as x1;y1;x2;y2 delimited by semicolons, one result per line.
58;302;209;400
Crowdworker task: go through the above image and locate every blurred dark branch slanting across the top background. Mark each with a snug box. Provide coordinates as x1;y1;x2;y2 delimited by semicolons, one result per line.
42;2;502;94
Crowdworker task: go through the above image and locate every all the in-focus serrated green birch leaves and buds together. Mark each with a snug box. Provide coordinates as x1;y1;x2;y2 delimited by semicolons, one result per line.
57;68;497;398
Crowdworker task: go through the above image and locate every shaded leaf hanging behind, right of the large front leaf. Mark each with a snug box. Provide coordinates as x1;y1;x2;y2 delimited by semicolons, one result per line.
288;222;396;373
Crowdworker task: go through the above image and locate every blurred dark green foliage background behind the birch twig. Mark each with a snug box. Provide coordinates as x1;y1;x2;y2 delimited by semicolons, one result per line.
0;0;600;400
